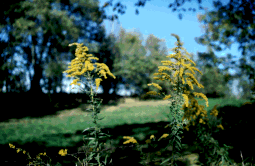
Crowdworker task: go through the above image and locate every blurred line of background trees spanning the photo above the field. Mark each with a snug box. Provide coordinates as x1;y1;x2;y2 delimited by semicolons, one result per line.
0;0;255;98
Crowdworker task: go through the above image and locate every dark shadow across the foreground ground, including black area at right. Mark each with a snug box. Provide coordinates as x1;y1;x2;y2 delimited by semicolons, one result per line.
0;99;254;165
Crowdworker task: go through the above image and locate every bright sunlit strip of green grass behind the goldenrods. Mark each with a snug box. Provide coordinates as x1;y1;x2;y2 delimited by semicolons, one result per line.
0;99;249;147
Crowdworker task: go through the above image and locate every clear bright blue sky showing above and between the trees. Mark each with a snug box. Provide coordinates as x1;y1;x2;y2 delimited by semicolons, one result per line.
3;0;249;98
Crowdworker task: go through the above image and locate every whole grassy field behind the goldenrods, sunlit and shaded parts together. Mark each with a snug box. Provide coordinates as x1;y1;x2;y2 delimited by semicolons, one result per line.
0;96;251;165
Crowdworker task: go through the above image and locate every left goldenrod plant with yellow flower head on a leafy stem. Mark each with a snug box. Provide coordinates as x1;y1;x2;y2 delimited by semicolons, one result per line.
60;43;116;166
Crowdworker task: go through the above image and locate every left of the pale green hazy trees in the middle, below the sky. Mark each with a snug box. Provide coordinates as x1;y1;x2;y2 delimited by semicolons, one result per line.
111;28;146;96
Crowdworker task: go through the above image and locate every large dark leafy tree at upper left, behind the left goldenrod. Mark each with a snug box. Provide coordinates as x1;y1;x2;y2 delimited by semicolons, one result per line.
0;0;103;93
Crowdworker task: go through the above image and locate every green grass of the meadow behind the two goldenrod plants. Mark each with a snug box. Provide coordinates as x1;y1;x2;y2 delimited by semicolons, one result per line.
0;96;252;165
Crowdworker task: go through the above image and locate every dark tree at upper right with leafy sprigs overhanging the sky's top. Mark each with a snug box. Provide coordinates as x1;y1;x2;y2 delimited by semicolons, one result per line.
99;0;255;100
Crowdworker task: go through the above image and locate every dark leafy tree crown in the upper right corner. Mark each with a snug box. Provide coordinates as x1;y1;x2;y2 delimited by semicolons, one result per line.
196;0;255;98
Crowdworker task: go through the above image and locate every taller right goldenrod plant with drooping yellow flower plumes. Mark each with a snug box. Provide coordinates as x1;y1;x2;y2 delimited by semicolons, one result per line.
124;34;235;165
